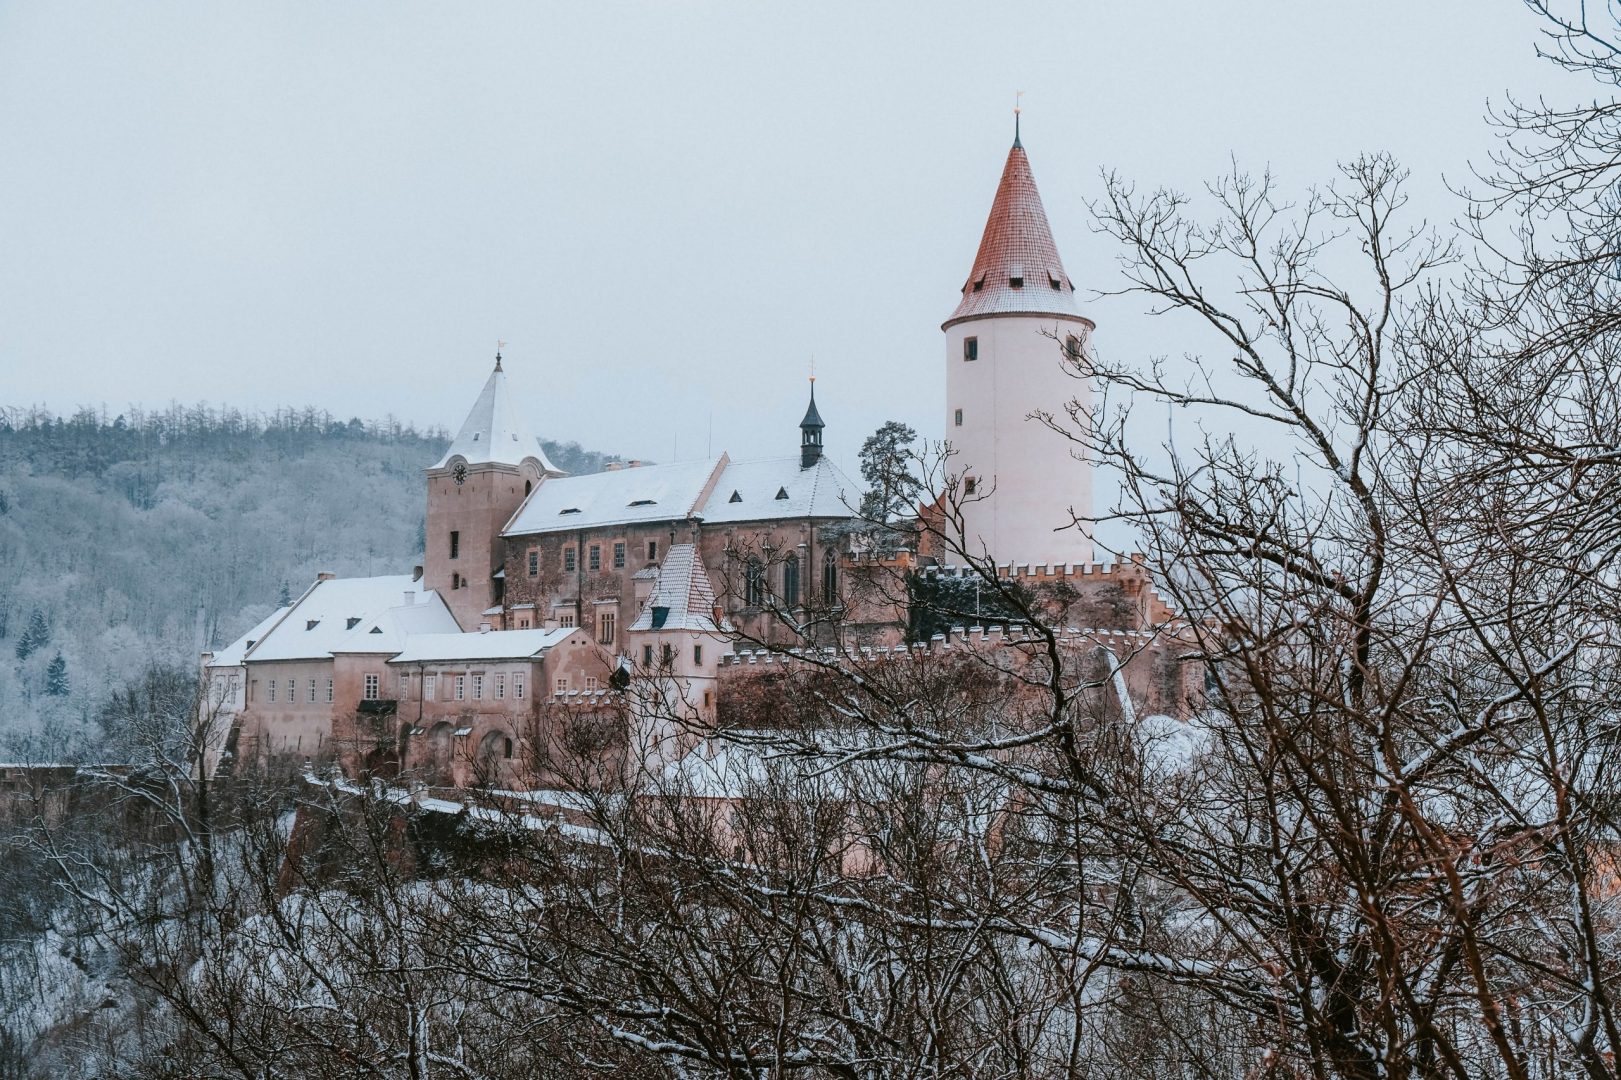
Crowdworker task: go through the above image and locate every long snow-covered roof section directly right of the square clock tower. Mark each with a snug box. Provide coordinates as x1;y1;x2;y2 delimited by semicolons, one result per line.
503;454;728;537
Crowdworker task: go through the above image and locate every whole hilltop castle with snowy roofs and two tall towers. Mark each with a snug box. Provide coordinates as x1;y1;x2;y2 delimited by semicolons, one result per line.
203;135;1190;786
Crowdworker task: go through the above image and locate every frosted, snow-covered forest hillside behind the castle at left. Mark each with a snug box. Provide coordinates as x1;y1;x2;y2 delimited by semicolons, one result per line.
0;404;605;761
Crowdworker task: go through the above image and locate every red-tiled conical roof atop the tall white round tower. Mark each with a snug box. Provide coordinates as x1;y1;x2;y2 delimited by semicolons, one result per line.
945;139;1081;326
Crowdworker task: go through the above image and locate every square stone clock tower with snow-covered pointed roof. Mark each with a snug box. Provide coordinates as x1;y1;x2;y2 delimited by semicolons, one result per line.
423;352;562;631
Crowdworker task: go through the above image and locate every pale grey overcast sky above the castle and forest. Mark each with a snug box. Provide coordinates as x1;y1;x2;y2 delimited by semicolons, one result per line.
0;0;1587;464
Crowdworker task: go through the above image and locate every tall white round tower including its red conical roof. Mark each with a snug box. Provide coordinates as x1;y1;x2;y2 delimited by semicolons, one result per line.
940;135;1094;566
